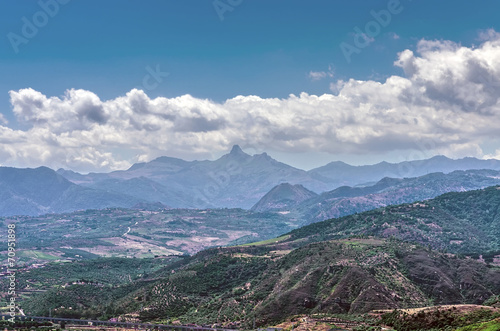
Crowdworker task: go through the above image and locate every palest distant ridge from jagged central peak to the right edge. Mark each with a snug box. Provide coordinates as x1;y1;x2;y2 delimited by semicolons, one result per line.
58;145;500;209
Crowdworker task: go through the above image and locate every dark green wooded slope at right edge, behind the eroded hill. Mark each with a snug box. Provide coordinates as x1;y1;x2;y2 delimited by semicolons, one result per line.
290;186;500;253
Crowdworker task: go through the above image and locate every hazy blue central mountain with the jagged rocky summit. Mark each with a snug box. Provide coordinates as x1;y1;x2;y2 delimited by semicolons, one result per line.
58;145;330;209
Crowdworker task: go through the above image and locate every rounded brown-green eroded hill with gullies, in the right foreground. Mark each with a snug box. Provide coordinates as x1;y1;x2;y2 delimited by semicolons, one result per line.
245;239;500;321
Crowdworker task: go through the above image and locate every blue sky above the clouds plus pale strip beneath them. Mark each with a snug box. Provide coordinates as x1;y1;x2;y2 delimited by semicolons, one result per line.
0;0;500;171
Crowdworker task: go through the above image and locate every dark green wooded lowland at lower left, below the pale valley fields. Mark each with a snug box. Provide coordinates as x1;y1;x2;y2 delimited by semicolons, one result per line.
0;257;182;318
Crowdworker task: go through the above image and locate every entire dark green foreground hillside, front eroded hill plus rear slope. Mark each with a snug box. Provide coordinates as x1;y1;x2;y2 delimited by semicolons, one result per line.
12;187;500;328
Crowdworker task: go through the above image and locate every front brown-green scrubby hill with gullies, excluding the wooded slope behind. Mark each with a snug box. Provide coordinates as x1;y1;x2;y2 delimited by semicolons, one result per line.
23;239;500;329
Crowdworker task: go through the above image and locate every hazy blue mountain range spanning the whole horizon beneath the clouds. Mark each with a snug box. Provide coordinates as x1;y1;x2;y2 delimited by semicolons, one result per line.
0;145;500;217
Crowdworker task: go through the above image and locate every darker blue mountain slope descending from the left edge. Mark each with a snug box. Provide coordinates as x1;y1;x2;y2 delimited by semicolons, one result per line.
0;167;143;216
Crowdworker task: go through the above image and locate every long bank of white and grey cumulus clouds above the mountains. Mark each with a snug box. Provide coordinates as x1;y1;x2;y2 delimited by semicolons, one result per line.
0;32;500;171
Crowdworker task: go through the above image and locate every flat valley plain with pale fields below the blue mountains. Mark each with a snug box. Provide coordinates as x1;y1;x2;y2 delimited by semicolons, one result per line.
0;208;298;265
